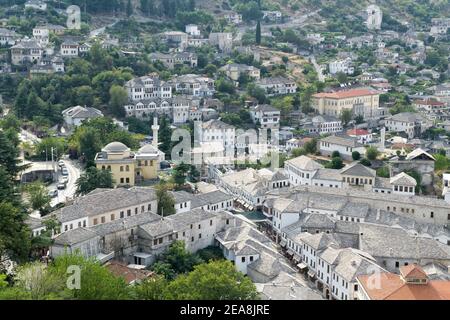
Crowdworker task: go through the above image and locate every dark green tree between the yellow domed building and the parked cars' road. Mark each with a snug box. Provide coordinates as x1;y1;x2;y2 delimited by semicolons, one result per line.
76;167;114;196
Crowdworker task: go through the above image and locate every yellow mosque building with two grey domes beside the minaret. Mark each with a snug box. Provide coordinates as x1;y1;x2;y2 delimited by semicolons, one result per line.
95;142;159;186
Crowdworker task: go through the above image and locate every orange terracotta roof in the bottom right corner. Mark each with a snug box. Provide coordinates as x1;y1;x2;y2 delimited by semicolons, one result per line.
358;272;450;300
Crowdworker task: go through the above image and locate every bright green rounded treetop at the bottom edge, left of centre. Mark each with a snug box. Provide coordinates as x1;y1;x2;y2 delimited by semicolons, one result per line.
166;260;258;300
